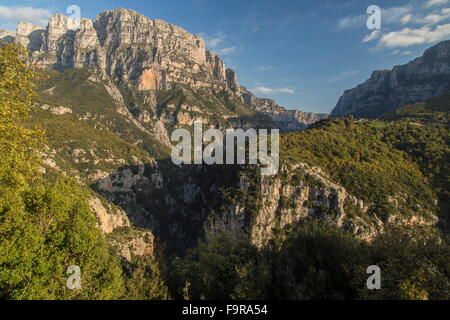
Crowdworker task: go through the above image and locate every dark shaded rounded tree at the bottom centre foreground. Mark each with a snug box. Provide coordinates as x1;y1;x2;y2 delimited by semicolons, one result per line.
170;232;270;300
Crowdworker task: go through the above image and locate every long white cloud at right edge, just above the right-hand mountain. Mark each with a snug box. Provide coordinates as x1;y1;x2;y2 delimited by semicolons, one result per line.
377;24;450;48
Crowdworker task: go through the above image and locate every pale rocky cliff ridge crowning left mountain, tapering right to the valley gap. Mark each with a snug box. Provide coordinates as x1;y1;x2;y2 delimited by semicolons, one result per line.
0;8;323;131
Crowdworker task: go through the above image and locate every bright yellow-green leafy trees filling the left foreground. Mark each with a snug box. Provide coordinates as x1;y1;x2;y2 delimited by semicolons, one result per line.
0;45;124;299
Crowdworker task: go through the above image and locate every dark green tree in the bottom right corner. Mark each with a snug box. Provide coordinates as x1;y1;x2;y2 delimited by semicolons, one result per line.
359;227;450;300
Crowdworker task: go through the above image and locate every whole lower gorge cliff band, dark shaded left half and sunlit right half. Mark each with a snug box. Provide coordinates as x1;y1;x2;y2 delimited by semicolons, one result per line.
89;156;437;251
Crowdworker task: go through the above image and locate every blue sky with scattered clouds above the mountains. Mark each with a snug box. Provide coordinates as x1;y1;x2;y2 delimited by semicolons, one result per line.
0;0;450;112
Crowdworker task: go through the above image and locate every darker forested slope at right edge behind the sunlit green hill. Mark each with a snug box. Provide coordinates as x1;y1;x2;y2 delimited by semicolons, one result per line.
382;94;450;235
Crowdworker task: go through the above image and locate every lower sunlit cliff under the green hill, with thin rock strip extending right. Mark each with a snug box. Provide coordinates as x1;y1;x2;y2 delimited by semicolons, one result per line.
204;163;437;247
